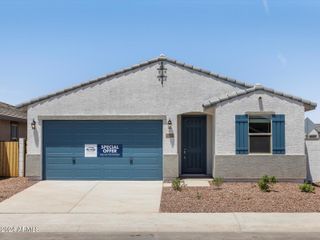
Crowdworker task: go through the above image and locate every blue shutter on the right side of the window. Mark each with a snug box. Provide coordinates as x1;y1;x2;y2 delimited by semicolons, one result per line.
272;114;286;154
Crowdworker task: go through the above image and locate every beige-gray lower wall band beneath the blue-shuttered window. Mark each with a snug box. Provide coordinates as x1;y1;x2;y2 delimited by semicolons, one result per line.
214;155;306;181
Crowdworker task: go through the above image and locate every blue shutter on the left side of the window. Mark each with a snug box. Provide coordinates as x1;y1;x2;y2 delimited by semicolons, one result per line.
236;115;249;154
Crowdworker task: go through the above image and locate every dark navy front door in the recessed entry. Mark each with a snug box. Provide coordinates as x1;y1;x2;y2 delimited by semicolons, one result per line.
181;116;207;174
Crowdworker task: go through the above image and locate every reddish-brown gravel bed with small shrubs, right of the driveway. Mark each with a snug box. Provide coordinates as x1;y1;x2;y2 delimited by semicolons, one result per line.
160;183;320;212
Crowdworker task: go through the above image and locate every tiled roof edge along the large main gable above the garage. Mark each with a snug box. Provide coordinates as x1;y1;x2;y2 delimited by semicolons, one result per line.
17;55;253;108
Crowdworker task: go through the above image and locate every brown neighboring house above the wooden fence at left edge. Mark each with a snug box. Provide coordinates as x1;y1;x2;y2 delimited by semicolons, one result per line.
0;102;27;141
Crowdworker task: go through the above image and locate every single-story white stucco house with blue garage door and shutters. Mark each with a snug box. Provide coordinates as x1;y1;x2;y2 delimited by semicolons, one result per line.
20;56;316;181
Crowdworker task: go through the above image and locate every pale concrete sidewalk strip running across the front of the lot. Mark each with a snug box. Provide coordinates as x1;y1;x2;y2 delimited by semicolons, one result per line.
0;213;320;233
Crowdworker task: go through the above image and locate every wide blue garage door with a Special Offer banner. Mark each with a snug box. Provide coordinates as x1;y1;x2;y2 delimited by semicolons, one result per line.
43;120;162;180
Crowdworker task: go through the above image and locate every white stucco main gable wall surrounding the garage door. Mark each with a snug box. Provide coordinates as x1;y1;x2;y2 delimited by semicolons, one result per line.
27;63;242;177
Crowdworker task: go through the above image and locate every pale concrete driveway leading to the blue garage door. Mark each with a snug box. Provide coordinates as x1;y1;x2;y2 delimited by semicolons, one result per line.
0;181;162;213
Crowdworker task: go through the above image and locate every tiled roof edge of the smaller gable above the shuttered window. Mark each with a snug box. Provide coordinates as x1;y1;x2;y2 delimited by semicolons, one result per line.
203;84;317;111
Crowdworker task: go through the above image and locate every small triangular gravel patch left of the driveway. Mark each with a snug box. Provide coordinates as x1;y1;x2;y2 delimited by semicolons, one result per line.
0;177;37;202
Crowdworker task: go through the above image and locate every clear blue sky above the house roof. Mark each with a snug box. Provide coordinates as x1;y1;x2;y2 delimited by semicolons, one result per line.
0;0;320;122
